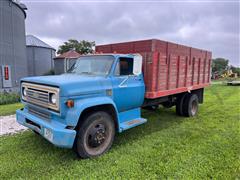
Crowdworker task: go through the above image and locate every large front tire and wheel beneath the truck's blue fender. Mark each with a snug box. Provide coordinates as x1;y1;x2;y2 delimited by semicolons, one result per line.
74;111;115;159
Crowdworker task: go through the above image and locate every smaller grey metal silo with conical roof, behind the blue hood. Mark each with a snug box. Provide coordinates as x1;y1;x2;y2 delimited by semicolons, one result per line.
26;35;56;76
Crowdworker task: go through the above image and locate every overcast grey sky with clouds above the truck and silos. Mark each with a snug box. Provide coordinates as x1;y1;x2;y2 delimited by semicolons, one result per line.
21;0;240;66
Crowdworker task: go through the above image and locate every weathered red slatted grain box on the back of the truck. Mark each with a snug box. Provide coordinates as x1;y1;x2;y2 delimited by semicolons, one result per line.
96;39;212;99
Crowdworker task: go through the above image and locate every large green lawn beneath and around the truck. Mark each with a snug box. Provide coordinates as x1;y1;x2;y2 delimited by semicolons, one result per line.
0;85;240;179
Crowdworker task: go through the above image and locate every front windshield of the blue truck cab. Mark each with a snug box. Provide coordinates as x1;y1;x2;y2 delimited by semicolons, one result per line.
68;56;114;76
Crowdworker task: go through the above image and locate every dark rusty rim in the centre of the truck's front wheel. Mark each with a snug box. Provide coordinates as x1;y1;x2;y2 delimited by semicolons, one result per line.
87;123;107;148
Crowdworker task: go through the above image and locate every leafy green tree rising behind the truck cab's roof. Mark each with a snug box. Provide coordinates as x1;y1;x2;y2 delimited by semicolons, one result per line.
57;39;95;54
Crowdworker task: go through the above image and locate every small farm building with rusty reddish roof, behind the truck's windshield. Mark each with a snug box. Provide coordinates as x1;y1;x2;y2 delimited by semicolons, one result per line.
54;50;80;74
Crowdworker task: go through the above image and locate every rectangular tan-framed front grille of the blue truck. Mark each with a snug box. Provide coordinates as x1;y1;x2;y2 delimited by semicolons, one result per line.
21;82;59;111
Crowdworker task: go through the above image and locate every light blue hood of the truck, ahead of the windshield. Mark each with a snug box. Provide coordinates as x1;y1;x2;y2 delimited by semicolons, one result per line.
21;74;111;96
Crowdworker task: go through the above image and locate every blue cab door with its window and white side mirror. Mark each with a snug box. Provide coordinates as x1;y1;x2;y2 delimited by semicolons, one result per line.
112;55;145;112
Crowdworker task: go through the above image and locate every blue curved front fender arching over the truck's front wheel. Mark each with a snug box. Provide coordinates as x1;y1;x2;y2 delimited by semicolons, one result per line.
65;96;117;127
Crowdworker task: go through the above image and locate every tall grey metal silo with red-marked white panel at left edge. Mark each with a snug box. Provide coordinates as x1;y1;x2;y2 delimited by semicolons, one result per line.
0;0;28;91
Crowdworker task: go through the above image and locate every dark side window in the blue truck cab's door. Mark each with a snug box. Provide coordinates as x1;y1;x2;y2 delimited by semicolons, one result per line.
114;58;133;76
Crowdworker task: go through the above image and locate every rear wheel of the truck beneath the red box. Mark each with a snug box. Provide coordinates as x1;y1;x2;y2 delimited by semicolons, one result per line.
182;94;198;117
